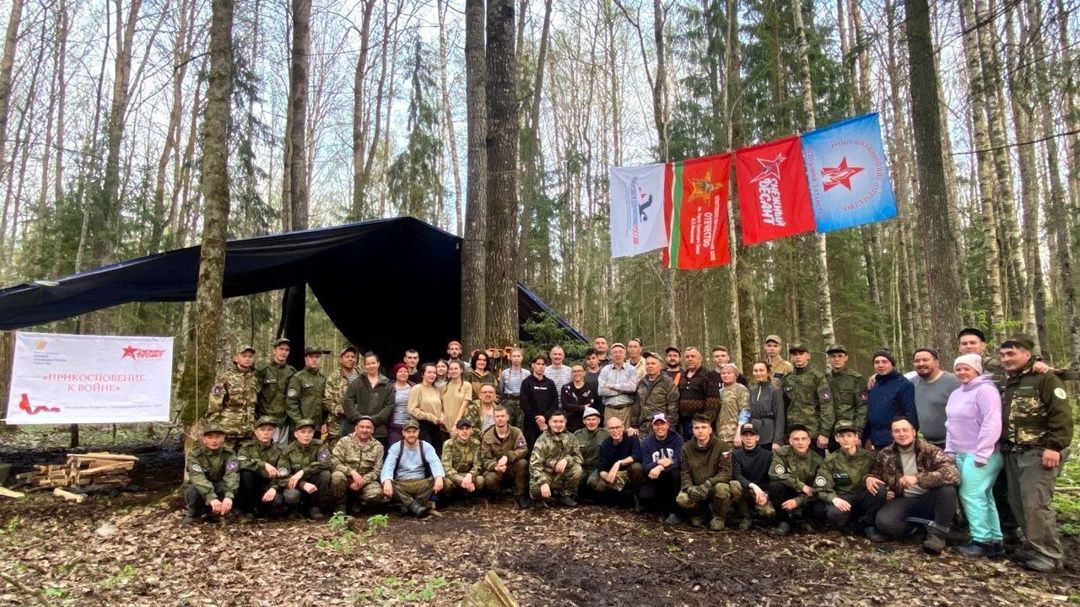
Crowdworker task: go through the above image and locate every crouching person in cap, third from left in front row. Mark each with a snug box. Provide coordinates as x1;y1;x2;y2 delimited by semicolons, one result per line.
279;418;330;521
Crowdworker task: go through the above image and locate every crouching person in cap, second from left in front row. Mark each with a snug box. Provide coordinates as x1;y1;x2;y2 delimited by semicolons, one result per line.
237;416;288;515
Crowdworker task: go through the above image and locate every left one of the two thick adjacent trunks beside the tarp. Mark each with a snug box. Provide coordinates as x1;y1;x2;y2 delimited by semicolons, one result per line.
461;0;491;352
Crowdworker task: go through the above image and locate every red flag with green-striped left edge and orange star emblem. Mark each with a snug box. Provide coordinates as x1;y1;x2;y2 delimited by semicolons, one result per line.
663;153;731;270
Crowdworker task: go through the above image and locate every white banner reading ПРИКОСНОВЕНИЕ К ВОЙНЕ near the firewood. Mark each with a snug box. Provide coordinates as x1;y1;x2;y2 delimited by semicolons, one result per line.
6;332;173;426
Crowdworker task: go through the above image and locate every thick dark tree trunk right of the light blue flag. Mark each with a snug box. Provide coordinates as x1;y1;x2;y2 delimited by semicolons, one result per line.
907;0;961;352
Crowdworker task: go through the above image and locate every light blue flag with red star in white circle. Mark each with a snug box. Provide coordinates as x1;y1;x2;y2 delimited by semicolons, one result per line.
802;113;896;232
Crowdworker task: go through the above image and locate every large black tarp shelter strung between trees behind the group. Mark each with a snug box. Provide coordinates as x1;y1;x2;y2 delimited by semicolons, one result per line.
0;217;584;364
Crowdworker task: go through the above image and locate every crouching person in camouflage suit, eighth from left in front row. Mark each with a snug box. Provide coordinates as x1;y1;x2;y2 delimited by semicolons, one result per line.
529;409;582;508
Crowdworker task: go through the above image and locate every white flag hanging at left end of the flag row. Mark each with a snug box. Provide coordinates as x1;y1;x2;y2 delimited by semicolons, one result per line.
610;163;671;257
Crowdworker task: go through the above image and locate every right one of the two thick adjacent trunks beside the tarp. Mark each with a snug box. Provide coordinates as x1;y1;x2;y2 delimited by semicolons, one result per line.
485;0;521;345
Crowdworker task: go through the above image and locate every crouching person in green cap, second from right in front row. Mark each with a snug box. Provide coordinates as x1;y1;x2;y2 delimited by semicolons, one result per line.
811;419;886;542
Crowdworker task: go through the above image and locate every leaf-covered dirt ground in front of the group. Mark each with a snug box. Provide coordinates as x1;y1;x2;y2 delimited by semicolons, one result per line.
0;436;1080;606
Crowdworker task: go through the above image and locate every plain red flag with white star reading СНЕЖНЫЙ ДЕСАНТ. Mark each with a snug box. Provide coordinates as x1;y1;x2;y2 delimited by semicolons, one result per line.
735;137;814;245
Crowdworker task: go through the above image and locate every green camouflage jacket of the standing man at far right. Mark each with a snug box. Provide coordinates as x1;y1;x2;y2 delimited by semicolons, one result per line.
1001;363;1072;451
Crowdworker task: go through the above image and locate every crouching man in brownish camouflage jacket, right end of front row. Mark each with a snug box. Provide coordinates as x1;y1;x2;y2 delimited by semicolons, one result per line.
866;413;960;554
